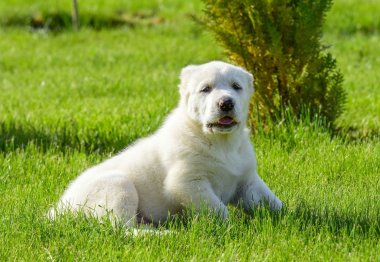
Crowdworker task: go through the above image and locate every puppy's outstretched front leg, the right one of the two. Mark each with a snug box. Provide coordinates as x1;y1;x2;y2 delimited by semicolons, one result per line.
241;172;282;211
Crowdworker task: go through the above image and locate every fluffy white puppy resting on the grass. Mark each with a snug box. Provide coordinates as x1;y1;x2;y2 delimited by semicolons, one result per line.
49;61;282;225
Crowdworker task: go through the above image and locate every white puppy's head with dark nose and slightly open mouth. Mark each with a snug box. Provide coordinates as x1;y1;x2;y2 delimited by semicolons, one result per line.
180;61;253;133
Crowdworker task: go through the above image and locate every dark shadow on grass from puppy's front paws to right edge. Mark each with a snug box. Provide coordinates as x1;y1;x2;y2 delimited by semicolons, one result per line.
160;201;380;236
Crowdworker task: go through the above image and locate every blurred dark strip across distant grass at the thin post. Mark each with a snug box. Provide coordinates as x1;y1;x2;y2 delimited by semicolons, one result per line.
0;10;164;33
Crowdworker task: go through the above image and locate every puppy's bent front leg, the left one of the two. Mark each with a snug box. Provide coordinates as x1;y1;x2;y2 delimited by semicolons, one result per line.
165;178;228;220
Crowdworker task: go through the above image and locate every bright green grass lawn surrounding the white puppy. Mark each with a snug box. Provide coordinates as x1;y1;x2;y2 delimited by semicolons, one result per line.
0;0;380;261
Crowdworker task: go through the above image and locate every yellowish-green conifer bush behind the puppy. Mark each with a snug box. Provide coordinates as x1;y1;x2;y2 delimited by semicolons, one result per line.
201;0;345;127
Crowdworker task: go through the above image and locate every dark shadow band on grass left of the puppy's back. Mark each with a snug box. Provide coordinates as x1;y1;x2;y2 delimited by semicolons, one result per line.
0;121;137;153
